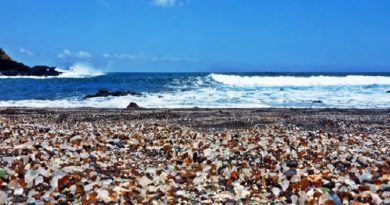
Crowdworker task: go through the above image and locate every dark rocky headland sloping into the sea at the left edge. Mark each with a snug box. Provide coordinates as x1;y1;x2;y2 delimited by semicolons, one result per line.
0;49;61;76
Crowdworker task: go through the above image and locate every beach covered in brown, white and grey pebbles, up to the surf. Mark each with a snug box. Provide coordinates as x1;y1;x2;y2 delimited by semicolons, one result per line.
0;108;390;205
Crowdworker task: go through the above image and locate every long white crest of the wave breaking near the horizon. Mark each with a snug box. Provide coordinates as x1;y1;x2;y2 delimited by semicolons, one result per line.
209;74;390;87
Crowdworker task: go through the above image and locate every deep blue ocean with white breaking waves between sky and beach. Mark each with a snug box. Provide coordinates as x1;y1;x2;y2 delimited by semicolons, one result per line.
0;67;390;108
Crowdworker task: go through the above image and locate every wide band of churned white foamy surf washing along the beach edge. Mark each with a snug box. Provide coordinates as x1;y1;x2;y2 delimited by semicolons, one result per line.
0;86;390;108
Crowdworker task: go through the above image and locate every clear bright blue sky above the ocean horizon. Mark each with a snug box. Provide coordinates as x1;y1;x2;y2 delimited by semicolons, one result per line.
0;0;390;72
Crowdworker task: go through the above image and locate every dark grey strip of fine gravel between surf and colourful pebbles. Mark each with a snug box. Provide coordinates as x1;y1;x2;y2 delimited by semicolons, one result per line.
0;107;390;131
